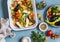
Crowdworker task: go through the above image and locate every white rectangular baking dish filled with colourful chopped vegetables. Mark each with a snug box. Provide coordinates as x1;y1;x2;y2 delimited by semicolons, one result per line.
7;0;38;30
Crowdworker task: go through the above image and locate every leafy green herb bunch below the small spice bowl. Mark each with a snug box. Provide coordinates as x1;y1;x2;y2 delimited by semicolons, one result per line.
31;31;45;42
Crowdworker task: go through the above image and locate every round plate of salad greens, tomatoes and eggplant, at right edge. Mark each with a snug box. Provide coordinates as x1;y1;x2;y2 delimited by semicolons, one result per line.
46;5;60;27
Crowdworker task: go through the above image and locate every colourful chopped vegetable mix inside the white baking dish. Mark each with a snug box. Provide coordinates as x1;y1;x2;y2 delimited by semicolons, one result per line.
10;0;35;28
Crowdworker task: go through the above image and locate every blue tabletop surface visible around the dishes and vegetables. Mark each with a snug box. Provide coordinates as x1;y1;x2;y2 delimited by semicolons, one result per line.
0;0;60;42
